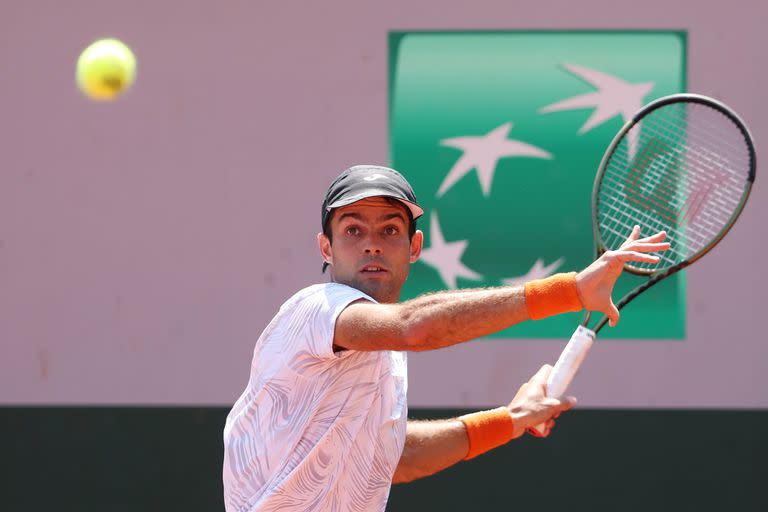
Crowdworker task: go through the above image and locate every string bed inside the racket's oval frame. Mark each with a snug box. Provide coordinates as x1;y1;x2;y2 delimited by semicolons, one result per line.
597;98;751;269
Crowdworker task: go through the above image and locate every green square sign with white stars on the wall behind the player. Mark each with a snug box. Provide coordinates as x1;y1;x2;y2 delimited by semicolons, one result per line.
389;31;686;339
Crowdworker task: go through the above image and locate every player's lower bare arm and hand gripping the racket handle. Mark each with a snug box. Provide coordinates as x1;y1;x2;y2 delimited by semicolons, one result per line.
392;365;576;484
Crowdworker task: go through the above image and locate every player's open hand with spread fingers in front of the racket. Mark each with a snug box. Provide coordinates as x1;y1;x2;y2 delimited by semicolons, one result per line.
576;226;669;327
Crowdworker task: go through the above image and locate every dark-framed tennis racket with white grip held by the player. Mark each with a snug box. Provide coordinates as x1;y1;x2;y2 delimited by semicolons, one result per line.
533;94;755;435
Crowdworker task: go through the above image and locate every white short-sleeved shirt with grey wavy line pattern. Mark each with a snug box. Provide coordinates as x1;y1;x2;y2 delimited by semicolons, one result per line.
223;283;408;512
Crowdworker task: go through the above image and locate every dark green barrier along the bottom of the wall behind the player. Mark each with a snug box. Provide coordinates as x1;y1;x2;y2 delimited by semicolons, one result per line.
0;407;768;512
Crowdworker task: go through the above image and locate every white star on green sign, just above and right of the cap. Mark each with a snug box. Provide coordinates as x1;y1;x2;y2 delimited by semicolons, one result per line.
437;123;552;197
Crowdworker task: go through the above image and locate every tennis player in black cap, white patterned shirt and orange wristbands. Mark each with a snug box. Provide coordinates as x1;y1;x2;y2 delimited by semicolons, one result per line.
223;165;668;512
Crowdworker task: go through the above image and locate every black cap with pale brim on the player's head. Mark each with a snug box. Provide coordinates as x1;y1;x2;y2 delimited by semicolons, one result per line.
322;165;424;230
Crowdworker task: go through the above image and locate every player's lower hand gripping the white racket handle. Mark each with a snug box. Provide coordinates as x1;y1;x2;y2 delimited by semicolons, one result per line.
507;364;576;438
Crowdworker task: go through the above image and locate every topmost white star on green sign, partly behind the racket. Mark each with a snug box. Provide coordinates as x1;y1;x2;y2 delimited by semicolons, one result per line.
539;64;654;157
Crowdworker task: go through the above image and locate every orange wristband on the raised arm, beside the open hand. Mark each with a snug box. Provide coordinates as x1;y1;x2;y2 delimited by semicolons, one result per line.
525;272;584;320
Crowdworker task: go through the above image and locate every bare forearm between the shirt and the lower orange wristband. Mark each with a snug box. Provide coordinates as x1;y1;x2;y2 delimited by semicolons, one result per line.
392;419;469;484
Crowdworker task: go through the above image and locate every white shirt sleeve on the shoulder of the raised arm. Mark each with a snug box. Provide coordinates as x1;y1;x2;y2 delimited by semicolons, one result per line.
290;283;376;360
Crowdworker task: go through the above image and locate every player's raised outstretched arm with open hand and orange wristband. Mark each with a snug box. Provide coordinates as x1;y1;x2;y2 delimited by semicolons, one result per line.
334;226;669;351
